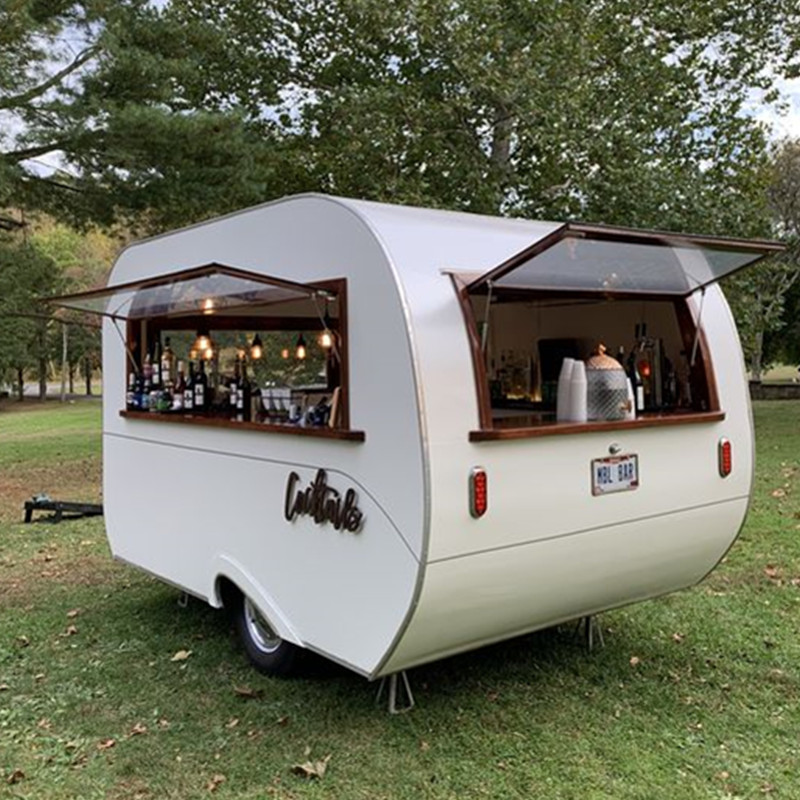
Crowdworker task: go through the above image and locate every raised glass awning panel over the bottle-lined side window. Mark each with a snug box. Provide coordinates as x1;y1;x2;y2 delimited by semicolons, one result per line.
43;264;329;319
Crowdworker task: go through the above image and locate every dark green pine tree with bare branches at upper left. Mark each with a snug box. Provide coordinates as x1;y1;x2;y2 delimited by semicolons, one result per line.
0;0;296;227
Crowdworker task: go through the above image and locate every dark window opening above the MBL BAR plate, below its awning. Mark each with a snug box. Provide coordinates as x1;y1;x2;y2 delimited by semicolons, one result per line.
469;291;720;429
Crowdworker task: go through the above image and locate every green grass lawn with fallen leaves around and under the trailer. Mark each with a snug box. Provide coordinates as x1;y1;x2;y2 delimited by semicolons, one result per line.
0;402;800;800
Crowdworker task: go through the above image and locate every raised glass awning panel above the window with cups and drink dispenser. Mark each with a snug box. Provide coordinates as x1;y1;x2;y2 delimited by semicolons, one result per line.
469;223;784;296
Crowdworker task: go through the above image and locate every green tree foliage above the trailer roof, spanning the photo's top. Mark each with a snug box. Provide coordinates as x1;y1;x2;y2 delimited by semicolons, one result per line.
0;0;800;234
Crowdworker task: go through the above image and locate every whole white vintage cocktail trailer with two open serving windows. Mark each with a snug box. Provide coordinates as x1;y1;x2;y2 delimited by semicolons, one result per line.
53;195;779;678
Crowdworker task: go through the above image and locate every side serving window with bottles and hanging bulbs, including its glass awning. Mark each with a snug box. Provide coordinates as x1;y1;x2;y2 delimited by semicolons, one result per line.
48;264;363;440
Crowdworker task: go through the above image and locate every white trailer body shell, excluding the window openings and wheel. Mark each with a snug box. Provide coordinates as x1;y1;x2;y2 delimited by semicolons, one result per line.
54;195;775;678
